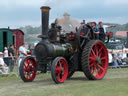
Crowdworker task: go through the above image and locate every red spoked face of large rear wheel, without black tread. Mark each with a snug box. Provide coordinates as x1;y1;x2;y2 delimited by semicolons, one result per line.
89;42;108;79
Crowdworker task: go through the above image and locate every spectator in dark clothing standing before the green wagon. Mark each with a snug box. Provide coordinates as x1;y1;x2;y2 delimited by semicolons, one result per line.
8;45;15;73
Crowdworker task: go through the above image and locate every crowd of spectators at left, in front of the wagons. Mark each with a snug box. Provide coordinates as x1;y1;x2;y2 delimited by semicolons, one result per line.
0;43;31;76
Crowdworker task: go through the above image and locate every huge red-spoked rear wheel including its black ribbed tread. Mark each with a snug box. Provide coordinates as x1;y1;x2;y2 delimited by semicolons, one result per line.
82;40;108;80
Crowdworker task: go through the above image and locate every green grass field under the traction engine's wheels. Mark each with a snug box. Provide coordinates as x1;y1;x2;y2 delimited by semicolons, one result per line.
0;68;128;96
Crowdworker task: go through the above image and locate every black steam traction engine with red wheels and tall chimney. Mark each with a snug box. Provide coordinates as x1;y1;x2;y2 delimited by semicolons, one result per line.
19;6;108;84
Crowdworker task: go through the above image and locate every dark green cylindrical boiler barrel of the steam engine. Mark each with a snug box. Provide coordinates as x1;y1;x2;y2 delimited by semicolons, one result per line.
34;42;72;60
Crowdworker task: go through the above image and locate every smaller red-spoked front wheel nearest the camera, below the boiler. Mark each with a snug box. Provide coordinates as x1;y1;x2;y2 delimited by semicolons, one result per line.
51;57;68;84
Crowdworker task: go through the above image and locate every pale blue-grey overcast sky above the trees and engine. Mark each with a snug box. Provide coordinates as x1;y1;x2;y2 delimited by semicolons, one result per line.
0;0;128;28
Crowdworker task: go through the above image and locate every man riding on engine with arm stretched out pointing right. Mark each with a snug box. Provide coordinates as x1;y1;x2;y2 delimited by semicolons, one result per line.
99;21;116;42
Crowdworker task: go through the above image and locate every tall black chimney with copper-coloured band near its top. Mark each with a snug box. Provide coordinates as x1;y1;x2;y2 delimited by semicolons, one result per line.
39;6;51;39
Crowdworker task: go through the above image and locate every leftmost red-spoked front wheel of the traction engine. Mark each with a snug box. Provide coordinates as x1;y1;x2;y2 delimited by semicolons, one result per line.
19;56;37;82
